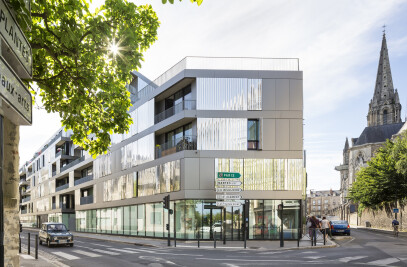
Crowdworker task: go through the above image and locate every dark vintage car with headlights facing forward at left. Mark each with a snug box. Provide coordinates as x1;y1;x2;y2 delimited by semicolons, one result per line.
38;222;73;247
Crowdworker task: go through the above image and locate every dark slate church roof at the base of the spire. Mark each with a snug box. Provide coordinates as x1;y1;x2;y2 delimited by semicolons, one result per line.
354;122;404;146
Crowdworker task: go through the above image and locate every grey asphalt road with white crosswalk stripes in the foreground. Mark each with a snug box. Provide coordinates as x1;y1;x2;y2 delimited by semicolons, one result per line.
22;229;407;267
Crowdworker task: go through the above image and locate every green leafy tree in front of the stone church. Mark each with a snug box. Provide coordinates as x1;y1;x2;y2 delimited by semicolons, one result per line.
349;136;407;215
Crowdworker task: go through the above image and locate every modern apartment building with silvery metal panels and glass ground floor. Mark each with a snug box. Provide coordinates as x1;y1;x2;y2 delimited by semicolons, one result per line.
20;57;306;240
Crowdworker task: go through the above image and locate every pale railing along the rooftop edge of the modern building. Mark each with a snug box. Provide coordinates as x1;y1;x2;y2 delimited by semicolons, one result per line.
131;57;300;101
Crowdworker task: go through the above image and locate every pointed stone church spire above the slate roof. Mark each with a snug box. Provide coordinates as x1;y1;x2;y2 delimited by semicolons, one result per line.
367;31;401;127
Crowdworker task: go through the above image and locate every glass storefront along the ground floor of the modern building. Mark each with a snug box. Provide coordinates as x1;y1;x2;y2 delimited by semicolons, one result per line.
76;200;301;240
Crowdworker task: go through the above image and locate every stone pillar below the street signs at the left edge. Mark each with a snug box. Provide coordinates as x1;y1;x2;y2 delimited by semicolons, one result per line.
3;117;20;267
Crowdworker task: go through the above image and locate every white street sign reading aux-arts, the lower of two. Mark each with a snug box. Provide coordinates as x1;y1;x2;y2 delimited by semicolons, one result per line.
0;57;32;124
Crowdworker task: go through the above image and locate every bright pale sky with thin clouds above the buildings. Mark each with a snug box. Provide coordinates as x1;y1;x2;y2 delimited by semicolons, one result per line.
20;0;407;193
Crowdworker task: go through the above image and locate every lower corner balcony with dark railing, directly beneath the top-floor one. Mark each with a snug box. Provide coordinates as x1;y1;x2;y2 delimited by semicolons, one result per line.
155;135;196;159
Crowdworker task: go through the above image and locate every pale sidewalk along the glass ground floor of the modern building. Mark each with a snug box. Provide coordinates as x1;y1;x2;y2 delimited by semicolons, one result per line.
22;229;337;250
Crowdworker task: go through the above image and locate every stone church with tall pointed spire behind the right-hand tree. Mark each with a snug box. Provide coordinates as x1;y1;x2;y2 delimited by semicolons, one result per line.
335;33;404;224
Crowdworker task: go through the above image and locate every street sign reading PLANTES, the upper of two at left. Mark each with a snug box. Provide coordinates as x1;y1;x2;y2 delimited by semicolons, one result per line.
0;0;32;77
